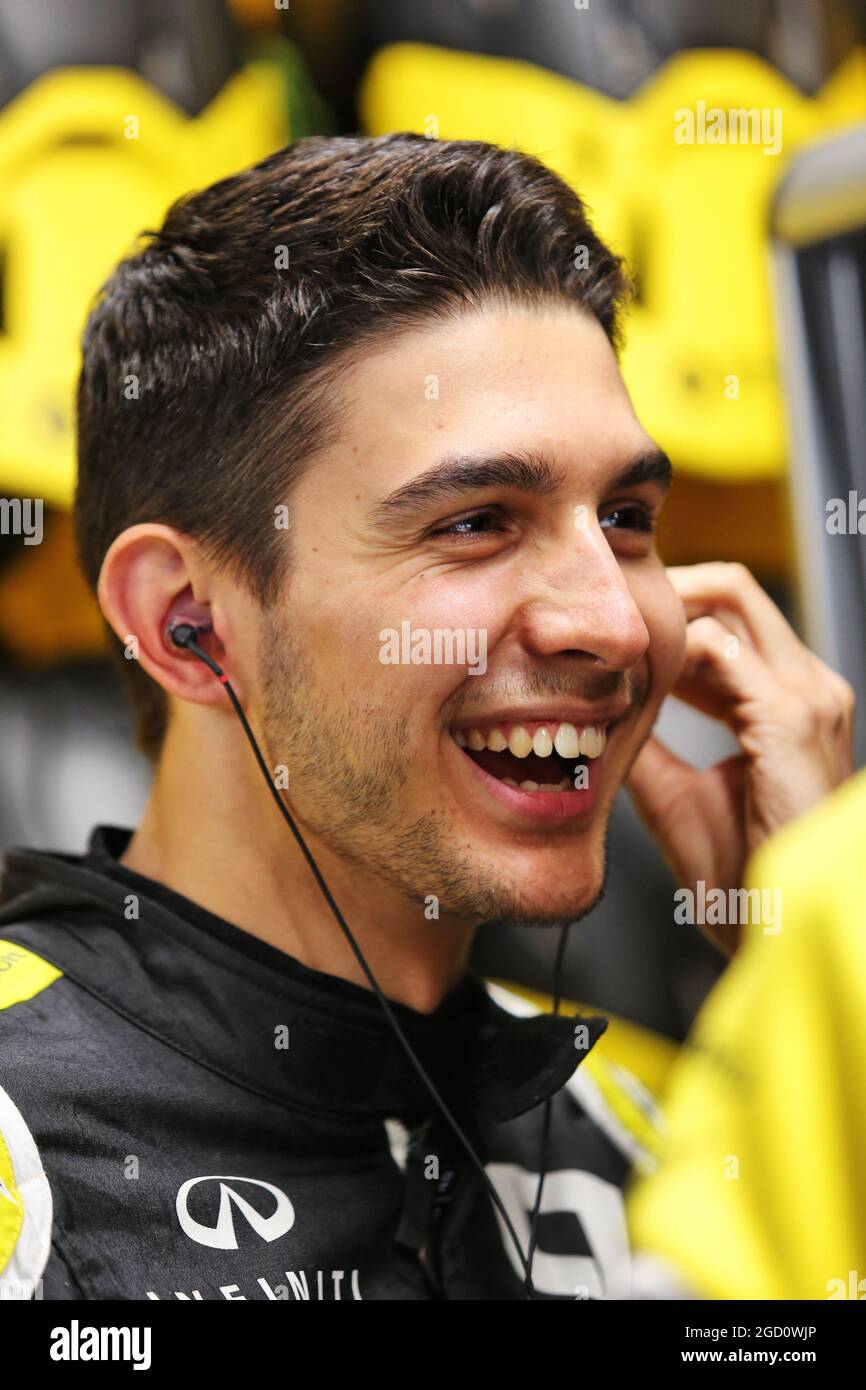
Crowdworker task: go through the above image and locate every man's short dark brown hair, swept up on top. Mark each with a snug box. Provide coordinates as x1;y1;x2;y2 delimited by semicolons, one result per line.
75;133;630;759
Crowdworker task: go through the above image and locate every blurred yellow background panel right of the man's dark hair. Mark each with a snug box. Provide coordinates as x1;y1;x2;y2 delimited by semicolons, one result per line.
361;43;866;482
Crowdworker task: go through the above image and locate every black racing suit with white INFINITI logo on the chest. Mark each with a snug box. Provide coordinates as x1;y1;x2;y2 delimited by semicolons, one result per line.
0;826;653;1300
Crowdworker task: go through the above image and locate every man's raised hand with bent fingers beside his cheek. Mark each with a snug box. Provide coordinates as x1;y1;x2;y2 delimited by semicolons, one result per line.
628;563;855;954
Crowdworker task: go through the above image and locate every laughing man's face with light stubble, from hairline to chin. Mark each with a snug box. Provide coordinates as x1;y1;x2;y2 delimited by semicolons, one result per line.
254;307;685;923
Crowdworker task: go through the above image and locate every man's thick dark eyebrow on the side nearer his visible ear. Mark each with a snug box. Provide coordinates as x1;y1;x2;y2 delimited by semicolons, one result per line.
370;450;564;525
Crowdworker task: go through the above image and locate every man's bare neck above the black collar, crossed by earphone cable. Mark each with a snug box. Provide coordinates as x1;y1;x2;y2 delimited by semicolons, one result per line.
121;721;473;1013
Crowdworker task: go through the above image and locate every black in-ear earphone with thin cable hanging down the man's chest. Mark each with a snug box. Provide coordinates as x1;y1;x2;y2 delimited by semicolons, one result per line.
168;619;570;1298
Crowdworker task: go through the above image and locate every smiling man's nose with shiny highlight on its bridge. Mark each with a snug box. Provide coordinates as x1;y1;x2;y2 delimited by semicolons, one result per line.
514;525;649;671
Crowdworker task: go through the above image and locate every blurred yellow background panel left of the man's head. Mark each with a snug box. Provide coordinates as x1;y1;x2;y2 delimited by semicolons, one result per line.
0;61;288;506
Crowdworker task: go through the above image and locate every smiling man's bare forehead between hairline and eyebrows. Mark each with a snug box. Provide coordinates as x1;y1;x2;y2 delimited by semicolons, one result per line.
308;307;663;520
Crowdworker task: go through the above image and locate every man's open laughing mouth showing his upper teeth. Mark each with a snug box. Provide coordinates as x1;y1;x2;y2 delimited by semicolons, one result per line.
452;720;607;794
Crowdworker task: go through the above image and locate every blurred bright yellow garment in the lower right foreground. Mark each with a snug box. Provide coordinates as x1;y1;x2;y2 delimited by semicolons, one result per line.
627;773;866;1300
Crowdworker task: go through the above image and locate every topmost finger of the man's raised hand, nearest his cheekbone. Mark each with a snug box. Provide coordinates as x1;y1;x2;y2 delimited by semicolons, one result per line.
667;562;812;682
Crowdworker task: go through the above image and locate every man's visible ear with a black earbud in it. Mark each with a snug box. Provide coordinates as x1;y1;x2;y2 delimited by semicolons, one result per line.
97;521;243;705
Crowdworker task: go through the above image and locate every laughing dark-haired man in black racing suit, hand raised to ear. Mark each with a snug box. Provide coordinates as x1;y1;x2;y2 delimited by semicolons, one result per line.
0;135;851;1300
